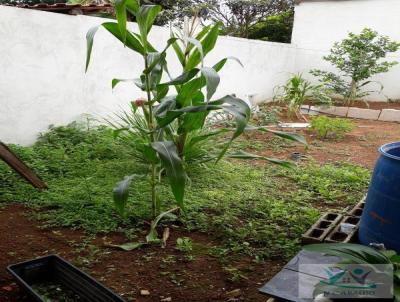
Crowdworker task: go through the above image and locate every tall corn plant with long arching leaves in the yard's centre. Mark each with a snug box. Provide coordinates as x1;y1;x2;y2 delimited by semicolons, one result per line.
86;0;304;241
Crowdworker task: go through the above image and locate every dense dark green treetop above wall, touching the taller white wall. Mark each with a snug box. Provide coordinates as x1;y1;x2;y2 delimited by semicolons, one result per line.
248;10;294;43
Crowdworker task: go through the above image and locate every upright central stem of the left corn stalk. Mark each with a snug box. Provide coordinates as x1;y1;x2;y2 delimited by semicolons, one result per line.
144;55;160;218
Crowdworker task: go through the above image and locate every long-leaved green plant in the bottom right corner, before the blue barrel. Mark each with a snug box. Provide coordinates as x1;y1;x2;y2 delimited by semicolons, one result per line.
304;243;400;302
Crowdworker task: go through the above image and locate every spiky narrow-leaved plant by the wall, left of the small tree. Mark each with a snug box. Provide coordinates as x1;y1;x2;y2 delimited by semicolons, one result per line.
274;73;331;120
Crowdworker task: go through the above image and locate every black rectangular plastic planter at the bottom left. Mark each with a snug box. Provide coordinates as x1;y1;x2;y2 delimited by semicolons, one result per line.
7;255;125;302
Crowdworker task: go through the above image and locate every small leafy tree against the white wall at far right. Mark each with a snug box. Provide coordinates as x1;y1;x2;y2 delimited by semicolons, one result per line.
311;28;400;105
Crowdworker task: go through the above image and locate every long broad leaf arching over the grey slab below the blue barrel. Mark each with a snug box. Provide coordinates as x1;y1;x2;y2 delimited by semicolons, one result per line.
304;243;390;264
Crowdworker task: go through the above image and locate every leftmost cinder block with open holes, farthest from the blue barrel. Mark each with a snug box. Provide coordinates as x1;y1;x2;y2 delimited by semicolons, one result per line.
302;213;343;244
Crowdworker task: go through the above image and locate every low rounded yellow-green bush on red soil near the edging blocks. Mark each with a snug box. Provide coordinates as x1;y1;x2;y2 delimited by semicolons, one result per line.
311;115;354;139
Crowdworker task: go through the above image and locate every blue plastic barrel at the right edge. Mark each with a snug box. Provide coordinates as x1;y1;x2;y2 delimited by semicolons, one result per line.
359;142;400;253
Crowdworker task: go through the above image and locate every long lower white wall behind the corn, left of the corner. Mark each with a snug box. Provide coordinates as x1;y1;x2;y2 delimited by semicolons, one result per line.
0;6;295;144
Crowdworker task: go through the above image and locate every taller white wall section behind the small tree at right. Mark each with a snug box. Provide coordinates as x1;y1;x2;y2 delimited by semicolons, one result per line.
292;0;400;101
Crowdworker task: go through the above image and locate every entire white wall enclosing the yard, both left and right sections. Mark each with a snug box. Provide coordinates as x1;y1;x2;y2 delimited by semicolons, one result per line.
0;0;400;145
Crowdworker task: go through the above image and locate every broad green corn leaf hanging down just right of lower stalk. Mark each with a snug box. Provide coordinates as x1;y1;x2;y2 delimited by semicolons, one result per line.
151;141;186;209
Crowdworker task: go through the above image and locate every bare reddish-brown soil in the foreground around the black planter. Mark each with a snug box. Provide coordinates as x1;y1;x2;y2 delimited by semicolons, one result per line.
0;204;283;302
